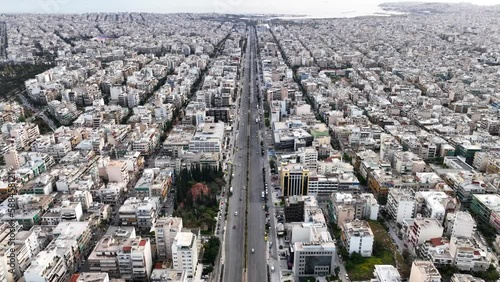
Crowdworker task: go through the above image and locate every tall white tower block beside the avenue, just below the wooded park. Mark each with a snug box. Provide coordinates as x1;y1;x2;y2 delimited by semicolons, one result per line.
172;232;198;277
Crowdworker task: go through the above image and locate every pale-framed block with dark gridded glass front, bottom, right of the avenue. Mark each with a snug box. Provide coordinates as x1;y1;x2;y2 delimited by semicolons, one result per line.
293;241;336;277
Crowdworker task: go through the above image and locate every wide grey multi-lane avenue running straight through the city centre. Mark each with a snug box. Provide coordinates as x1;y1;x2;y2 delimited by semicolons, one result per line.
221;25;267;282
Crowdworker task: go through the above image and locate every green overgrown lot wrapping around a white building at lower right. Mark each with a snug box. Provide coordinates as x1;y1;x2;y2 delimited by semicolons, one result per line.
345;221;410;280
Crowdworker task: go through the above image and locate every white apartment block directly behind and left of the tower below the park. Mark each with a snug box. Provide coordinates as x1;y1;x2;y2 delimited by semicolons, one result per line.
155;217;182;260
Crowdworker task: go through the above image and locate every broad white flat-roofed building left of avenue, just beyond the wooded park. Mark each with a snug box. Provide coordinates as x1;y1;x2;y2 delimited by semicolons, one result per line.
189;122;224;153
